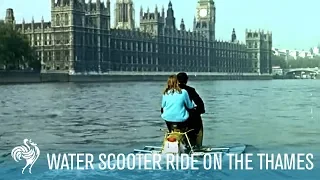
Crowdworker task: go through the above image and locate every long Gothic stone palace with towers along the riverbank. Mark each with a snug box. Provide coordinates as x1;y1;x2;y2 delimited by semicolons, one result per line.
5;0;272;74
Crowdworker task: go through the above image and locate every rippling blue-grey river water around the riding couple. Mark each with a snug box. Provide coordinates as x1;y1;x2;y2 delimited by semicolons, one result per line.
0;80;320;180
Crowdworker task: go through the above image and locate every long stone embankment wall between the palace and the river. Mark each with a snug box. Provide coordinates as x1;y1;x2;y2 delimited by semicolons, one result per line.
0;72;272;84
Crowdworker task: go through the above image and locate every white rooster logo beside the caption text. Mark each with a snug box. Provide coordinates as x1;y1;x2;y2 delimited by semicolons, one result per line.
11;139;40;174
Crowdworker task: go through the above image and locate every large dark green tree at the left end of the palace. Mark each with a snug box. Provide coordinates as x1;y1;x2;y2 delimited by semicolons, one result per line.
0;22;40;70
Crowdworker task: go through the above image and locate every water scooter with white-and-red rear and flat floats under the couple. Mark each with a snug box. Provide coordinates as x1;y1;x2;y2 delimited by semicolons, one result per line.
134;128;246;156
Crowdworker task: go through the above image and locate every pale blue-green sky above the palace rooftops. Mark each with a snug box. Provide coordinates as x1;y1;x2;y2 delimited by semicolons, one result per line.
0;0;320;50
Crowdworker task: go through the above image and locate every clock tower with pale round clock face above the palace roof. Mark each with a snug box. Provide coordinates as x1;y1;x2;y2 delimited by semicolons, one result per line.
193;0;216;41
